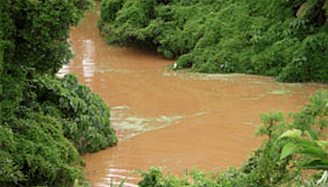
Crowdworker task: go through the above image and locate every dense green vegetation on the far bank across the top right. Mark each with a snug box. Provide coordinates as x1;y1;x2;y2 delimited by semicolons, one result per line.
99;0;328;83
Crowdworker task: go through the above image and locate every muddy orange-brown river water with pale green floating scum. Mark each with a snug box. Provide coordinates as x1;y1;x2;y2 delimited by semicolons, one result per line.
59;5;327;186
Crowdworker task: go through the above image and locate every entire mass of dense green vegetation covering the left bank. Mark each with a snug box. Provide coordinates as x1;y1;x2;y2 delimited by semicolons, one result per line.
0;0;117;187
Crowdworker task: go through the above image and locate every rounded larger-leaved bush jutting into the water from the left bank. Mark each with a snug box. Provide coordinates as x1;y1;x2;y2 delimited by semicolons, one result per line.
32;75;117;153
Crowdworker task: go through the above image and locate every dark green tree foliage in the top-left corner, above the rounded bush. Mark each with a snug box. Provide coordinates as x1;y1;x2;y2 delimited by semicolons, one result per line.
0;0;91;120
